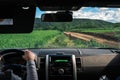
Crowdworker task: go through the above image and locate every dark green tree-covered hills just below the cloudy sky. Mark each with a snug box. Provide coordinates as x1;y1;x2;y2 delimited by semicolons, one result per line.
34;18;120;31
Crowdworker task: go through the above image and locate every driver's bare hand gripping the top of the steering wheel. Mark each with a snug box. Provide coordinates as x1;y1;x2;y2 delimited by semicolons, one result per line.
23;50;36;61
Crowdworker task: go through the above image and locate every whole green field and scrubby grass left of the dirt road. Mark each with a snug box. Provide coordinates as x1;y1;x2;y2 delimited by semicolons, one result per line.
0;30;106;49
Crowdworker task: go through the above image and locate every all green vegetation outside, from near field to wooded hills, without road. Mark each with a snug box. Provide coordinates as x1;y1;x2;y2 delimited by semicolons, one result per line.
0;18;120;48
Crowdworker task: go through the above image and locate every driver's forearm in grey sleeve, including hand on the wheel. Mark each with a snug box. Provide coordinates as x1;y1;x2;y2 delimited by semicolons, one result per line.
23;50;38;80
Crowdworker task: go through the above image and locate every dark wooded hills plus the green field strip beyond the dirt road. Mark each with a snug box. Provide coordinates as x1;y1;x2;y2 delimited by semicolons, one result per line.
34;18;120;38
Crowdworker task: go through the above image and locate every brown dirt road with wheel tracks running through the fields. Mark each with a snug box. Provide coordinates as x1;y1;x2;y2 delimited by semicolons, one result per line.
64;32;120;47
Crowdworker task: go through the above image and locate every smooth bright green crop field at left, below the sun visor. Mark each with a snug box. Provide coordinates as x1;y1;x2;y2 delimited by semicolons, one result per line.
0;30;60;48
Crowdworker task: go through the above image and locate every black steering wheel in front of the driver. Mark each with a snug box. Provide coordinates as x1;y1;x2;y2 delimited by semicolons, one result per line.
0;49;26;77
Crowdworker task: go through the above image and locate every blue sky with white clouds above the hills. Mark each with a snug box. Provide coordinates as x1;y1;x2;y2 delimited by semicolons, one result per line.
36;7;120;23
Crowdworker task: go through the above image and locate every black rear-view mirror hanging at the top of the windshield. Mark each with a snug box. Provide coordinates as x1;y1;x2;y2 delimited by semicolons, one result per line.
41;12;73;22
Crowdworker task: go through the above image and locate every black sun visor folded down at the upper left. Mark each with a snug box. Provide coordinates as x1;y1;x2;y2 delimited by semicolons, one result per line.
0;5;36;33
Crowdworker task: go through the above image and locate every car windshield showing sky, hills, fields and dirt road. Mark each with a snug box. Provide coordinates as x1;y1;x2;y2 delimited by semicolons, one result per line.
0;7;120;48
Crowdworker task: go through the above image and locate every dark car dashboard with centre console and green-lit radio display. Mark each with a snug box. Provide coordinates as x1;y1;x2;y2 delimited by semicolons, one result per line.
0;49;120;80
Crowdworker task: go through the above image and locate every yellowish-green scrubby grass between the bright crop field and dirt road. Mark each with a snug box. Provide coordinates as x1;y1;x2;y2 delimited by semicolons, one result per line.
43;34;108;48
